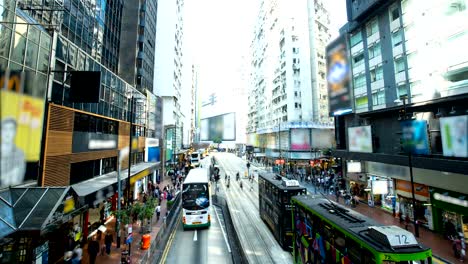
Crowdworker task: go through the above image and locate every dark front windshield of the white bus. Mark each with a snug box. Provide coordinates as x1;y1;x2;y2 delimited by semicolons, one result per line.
182;183;210;210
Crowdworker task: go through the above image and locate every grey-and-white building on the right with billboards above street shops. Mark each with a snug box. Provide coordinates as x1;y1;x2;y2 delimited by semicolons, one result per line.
327;0;468;238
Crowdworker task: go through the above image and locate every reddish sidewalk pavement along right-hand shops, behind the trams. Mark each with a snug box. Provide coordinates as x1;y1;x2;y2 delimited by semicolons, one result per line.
249;164;460;263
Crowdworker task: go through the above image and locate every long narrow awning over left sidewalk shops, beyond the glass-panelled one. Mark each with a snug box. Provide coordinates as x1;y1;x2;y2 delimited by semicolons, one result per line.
71;162;160;207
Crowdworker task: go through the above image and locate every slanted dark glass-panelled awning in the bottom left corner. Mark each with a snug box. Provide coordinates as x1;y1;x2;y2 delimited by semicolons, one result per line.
0;187;79;238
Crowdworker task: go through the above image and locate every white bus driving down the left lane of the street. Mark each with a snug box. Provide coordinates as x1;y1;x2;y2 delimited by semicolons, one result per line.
182;168;211;230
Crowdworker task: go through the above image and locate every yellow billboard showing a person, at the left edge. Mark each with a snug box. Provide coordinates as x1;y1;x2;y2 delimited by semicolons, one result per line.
0;72;44;188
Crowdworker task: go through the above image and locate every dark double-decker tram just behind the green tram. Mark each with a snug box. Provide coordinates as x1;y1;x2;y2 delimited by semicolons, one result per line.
258;172;307;251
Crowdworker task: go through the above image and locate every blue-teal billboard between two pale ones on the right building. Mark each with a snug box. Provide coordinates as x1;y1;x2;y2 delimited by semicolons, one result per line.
401;120;429;155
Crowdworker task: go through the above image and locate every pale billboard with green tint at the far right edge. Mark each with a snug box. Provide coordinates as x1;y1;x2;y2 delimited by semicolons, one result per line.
440;115;468;158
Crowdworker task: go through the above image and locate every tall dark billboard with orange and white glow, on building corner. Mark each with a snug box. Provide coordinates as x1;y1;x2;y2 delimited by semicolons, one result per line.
326;35;352;116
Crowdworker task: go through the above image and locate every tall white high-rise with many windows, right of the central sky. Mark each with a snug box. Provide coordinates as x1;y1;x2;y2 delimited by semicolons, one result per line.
247;0;333;165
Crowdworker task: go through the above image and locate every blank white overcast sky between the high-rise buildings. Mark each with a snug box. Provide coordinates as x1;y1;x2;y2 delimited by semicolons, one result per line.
186;0;346;99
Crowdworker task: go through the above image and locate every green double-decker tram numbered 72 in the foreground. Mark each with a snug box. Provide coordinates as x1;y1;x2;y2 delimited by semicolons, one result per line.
291;195;432;264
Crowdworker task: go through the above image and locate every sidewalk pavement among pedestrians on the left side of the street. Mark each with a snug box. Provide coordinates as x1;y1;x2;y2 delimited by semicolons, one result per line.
81;177;172;264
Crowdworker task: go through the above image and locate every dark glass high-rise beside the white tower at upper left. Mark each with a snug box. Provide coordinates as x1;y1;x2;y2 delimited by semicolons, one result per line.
119;0;158;92
